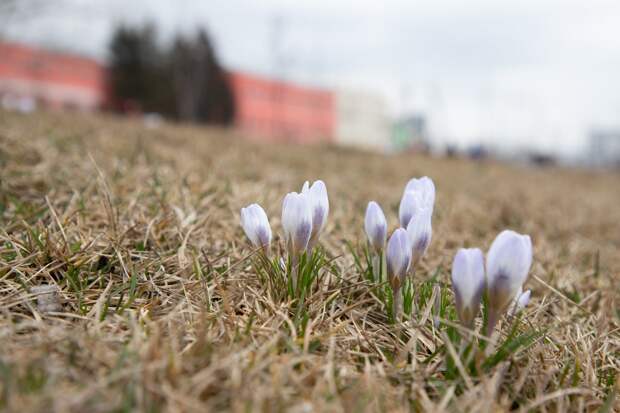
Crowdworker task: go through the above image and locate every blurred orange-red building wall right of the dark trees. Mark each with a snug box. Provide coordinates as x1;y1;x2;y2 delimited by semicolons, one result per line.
230;72;334;143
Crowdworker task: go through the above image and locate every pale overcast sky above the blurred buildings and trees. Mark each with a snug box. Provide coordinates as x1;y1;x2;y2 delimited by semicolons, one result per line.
5;0;620;155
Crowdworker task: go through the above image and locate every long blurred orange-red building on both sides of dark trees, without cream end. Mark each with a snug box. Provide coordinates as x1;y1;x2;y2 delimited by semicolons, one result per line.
0;42;335;143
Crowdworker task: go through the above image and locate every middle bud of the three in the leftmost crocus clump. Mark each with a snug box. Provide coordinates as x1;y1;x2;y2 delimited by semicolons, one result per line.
282;192;312;255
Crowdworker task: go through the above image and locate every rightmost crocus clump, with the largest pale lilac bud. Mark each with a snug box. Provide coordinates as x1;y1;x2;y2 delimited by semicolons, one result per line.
452;230;532;335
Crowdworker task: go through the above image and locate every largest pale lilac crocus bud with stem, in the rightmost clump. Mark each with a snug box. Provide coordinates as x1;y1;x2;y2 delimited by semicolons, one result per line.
487;230;532;335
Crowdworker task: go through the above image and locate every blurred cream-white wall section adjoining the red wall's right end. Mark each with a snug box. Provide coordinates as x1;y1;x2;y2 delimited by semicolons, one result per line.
335;90;391;152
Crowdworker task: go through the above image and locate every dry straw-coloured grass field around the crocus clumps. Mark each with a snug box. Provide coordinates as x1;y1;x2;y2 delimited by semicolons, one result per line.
0;113;620;412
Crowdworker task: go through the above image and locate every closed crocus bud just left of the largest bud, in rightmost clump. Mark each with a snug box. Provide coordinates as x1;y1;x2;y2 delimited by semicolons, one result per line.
452;248;485;327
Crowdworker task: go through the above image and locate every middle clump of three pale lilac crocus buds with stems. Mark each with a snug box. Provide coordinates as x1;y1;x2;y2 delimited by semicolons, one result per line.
364;176;435;317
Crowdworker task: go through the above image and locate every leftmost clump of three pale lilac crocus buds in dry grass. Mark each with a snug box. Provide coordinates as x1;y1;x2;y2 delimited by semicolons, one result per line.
241;180;329;286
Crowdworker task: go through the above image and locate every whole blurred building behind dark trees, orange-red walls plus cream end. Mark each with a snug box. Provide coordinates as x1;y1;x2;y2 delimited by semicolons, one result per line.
0;43;390;151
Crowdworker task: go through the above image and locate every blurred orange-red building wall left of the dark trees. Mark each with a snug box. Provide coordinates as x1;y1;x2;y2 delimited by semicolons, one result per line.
0;43;106;110
